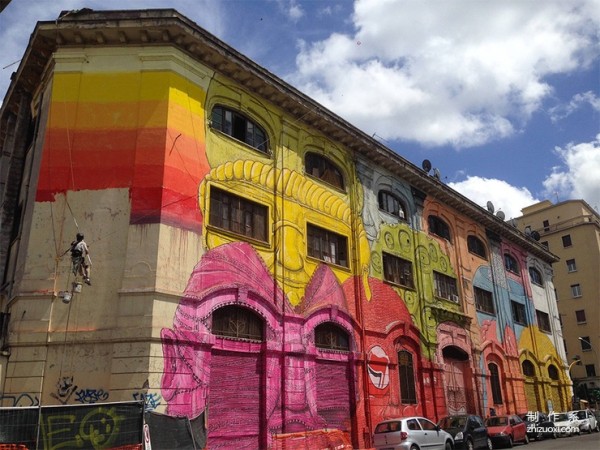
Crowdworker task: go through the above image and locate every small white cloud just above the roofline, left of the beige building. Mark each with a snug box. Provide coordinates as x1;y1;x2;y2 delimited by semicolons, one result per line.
448;176;540;219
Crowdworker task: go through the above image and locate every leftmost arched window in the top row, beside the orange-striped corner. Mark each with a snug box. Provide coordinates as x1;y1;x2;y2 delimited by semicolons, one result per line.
211;106;269;153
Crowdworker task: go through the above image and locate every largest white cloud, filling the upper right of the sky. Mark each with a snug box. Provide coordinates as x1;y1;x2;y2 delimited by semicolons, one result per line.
290;0;600;147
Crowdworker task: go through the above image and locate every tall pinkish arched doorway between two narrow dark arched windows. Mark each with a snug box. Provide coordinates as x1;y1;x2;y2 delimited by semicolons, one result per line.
442;345;474;414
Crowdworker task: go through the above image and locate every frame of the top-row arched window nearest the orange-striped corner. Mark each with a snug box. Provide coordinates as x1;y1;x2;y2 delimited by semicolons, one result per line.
210;104;270;155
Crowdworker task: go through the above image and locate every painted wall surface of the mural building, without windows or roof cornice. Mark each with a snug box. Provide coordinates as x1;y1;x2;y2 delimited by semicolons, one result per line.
3;44;567;448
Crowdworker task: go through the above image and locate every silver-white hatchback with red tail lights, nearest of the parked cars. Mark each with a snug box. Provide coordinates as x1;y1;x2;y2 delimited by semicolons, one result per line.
373;417;454;450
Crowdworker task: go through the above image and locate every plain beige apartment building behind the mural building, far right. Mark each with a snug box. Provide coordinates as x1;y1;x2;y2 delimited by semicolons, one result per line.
517;200;600;405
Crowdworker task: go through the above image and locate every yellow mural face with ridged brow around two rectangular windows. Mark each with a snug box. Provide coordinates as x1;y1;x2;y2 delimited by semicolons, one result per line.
199;160;369;305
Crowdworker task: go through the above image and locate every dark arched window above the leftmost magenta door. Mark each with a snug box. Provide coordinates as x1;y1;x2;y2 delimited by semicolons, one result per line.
212;305;263;341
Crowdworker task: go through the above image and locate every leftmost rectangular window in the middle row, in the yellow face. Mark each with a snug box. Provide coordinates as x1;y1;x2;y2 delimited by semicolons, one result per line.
209;187;268;242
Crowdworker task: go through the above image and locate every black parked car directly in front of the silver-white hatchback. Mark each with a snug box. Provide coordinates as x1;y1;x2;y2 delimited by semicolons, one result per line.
438;414;493;450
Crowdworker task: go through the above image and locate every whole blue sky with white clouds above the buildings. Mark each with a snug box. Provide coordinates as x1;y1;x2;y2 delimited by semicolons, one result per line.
0;0;600;219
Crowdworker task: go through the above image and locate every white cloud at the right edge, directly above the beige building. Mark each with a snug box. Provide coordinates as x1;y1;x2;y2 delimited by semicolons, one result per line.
544;134;600;211
